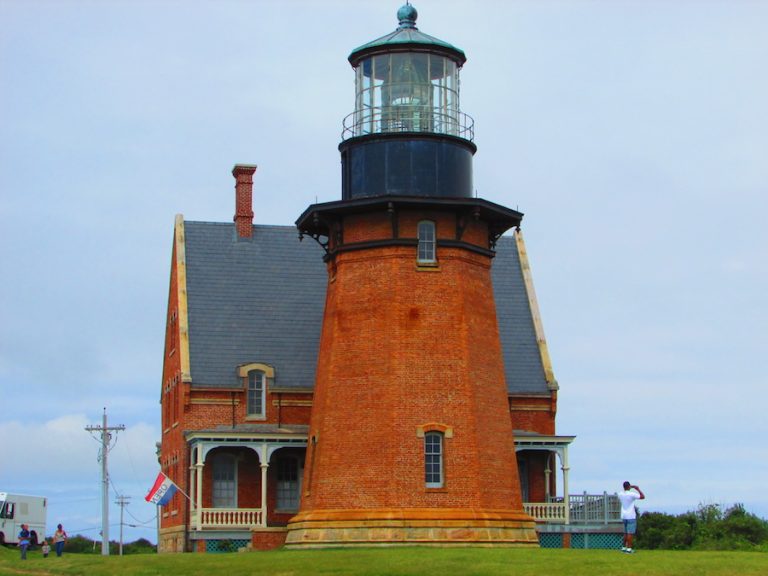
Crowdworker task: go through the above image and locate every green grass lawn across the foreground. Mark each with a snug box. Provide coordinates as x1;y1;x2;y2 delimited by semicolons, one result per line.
0;548;768;576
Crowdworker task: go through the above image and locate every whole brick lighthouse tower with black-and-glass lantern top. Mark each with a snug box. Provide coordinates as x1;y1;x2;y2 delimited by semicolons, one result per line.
286;4;538;547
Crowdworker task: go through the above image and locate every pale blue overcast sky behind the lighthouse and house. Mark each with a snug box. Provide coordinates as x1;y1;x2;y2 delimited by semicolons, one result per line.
0;0;768;541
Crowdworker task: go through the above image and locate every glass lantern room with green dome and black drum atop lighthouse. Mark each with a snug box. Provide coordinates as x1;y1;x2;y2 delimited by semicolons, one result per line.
339;4;476;200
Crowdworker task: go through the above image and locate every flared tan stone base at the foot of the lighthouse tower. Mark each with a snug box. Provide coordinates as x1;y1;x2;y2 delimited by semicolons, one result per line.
285;508;539;548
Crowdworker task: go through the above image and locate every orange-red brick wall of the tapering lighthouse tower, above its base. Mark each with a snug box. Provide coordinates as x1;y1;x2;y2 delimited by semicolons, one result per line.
302;211;521;510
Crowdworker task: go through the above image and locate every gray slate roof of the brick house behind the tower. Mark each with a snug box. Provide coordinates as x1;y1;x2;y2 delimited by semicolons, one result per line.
184;221;548;393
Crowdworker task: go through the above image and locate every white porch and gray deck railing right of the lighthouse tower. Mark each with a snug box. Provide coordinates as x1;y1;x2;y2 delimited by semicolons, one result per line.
523;492;621;524
